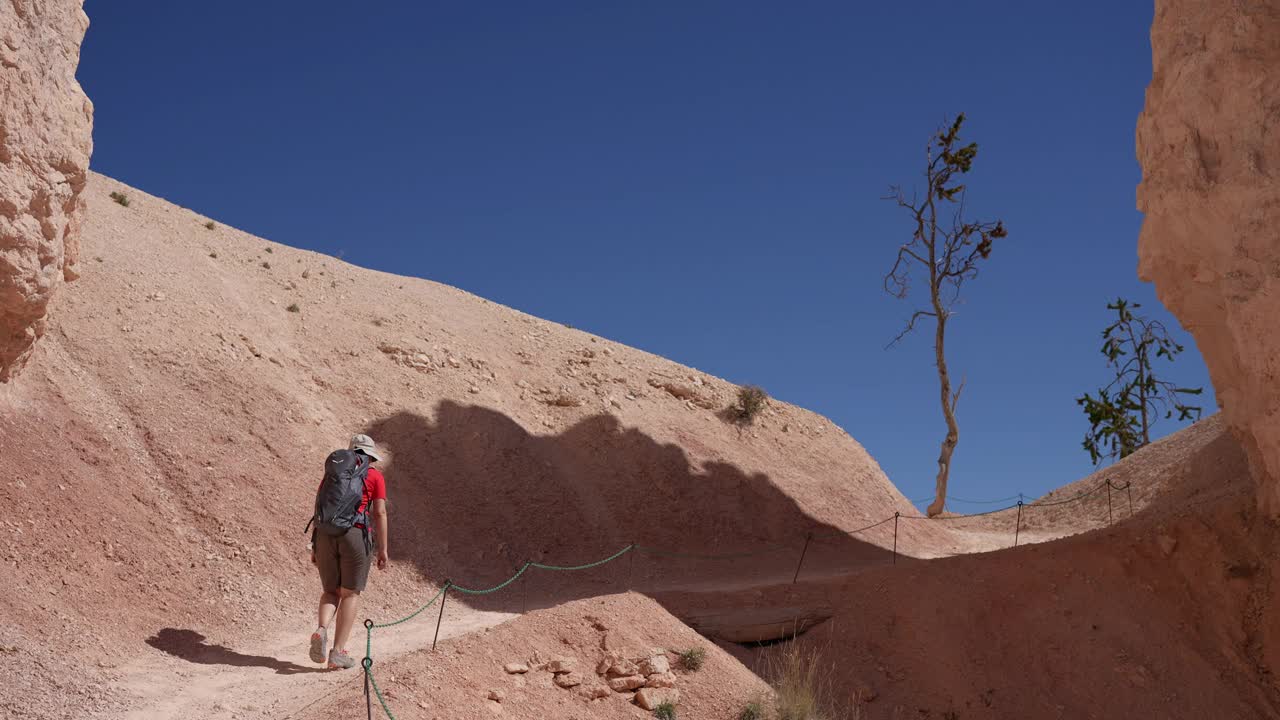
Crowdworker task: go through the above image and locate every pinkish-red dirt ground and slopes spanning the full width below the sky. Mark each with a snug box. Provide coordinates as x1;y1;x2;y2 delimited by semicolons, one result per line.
0;176;1280;720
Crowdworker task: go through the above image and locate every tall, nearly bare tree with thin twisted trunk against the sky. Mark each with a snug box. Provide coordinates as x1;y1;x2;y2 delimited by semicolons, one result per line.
884;113;1007;518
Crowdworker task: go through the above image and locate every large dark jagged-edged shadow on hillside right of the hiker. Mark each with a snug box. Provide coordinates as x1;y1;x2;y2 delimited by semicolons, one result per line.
366;401;890;611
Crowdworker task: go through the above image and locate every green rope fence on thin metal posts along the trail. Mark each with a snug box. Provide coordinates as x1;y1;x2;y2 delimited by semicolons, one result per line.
360;479;1133;720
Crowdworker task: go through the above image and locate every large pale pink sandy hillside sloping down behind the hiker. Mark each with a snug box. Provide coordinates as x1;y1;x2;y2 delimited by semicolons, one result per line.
0;174;941;716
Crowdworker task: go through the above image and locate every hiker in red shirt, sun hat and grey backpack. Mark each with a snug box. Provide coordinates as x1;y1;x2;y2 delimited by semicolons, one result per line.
307;434;388;669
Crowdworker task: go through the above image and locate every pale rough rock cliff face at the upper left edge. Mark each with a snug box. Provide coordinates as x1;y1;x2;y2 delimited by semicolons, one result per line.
0;0;93;382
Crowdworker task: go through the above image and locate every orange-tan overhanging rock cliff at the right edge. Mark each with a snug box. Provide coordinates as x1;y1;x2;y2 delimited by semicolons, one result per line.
1138;0;1280;515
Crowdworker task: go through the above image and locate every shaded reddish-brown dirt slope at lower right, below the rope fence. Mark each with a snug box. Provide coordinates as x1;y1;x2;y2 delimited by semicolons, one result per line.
657;418;1280;720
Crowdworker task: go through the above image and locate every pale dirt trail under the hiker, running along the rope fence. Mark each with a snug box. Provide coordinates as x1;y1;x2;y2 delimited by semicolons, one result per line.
116;509;1009;720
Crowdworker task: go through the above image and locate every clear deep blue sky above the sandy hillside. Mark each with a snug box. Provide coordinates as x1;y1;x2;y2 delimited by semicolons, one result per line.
79;0;1215;510
